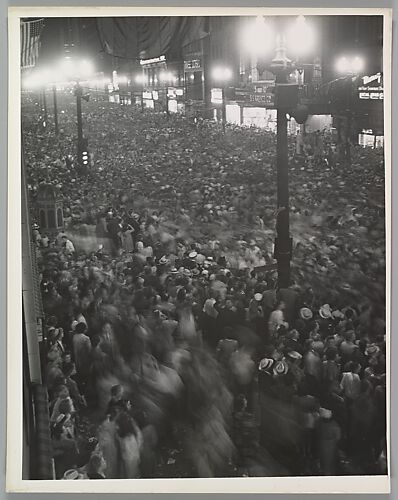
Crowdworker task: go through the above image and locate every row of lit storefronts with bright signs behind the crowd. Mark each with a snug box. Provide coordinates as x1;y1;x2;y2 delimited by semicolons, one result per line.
104;17;383;145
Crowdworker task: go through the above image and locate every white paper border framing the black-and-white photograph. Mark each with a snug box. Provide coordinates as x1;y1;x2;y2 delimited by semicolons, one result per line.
6;6;392;494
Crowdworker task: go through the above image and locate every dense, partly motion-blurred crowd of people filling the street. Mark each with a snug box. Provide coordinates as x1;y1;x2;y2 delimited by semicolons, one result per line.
23;95;386;479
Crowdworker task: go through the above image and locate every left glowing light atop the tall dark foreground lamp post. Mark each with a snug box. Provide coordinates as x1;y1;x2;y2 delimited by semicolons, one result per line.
241;16;275;56
